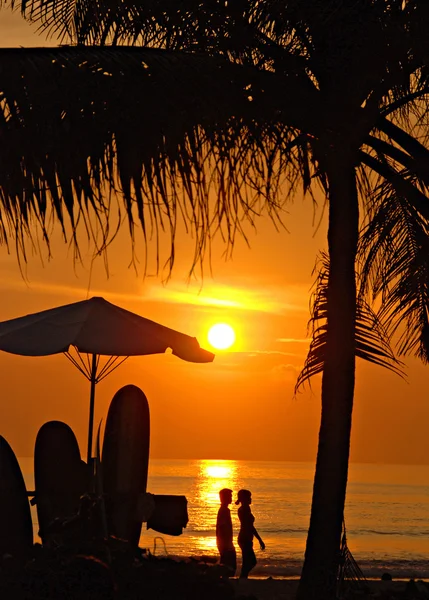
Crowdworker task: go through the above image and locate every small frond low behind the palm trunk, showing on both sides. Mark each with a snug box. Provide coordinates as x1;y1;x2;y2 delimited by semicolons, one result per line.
295;253;403;392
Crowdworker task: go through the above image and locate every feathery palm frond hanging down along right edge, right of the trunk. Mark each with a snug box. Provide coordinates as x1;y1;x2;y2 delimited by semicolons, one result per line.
360;172;429;362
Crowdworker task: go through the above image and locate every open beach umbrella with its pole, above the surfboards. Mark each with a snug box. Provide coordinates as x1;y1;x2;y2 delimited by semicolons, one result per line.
0;297;214;462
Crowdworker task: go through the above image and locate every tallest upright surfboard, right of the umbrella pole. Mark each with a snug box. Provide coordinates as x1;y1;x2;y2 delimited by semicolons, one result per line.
101;385;150;545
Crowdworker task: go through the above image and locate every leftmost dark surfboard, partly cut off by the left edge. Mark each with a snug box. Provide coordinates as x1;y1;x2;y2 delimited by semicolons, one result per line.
0;436;33;557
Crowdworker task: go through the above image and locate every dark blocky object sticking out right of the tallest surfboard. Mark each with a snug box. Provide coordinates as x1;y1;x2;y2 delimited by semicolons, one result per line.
147;494;189;536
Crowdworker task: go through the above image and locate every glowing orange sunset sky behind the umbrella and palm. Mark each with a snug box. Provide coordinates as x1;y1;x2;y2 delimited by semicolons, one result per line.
0;10;429;463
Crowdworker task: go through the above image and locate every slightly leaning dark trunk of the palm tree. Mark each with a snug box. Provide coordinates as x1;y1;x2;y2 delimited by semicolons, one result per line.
297;152;359;600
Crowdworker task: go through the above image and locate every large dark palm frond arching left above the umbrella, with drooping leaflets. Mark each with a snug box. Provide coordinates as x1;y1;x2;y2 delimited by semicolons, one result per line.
0;47;314;270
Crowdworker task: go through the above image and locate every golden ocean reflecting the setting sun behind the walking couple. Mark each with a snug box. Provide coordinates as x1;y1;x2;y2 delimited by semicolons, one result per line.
20;459;429;579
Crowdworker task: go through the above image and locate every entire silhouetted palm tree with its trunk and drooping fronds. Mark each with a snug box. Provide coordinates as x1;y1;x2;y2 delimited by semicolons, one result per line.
0;0;429;600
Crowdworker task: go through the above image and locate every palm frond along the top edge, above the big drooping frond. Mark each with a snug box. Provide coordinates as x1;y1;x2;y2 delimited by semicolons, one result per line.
2;0;302;56
